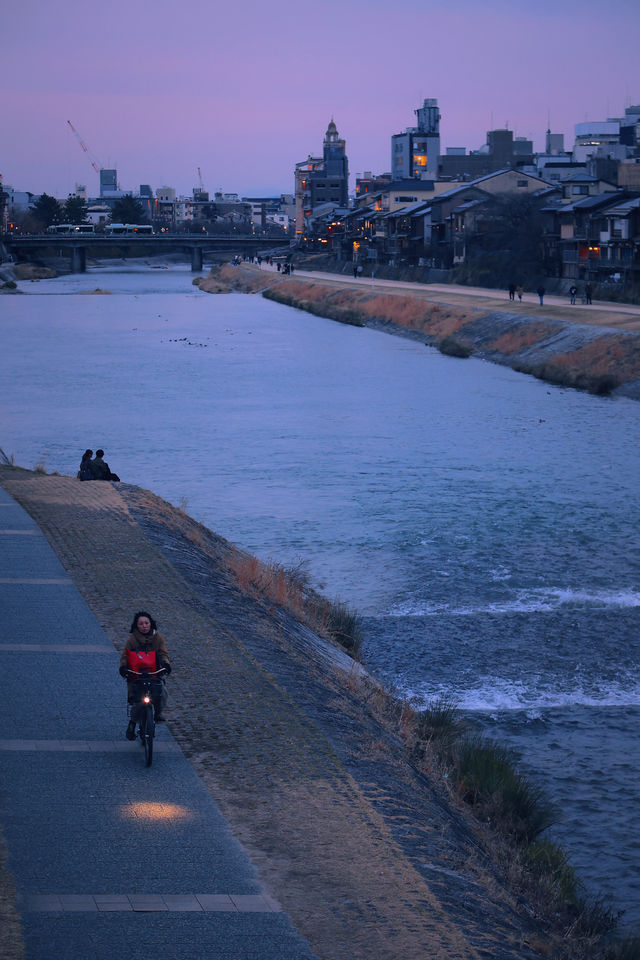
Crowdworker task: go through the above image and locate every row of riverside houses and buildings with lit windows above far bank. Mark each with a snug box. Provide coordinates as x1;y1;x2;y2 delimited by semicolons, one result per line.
296;100;640;286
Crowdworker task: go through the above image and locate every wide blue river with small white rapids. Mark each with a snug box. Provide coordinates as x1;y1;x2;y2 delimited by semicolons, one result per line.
0;264;640;927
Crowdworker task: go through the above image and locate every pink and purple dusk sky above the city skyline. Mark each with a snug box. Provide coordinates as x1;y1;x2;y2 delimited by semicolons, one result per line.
5;0;640;198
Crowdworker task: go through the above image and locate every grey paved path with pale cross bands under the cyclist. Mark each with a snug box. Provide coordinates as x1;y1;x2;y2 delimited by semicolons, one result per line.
0;488;314;960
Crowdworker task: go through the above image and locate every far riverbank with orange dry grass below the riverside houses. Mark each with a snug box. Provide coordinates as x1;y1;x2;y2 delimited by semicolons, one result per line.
194;264;640;400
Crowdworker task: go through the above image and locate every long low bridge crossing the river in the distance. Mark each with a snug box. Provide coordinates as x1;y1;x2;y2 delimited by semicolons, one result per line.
0;233;291;273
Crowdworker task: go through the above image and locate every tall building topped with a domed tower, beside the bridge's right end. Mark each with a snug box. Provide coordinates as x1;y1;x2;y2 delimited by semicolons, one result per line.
294;119;349;236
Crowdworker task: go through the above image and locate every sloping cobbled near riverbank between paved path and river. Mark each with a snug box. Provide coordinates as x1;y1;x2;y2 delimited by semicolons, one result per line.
0;467;632;960
